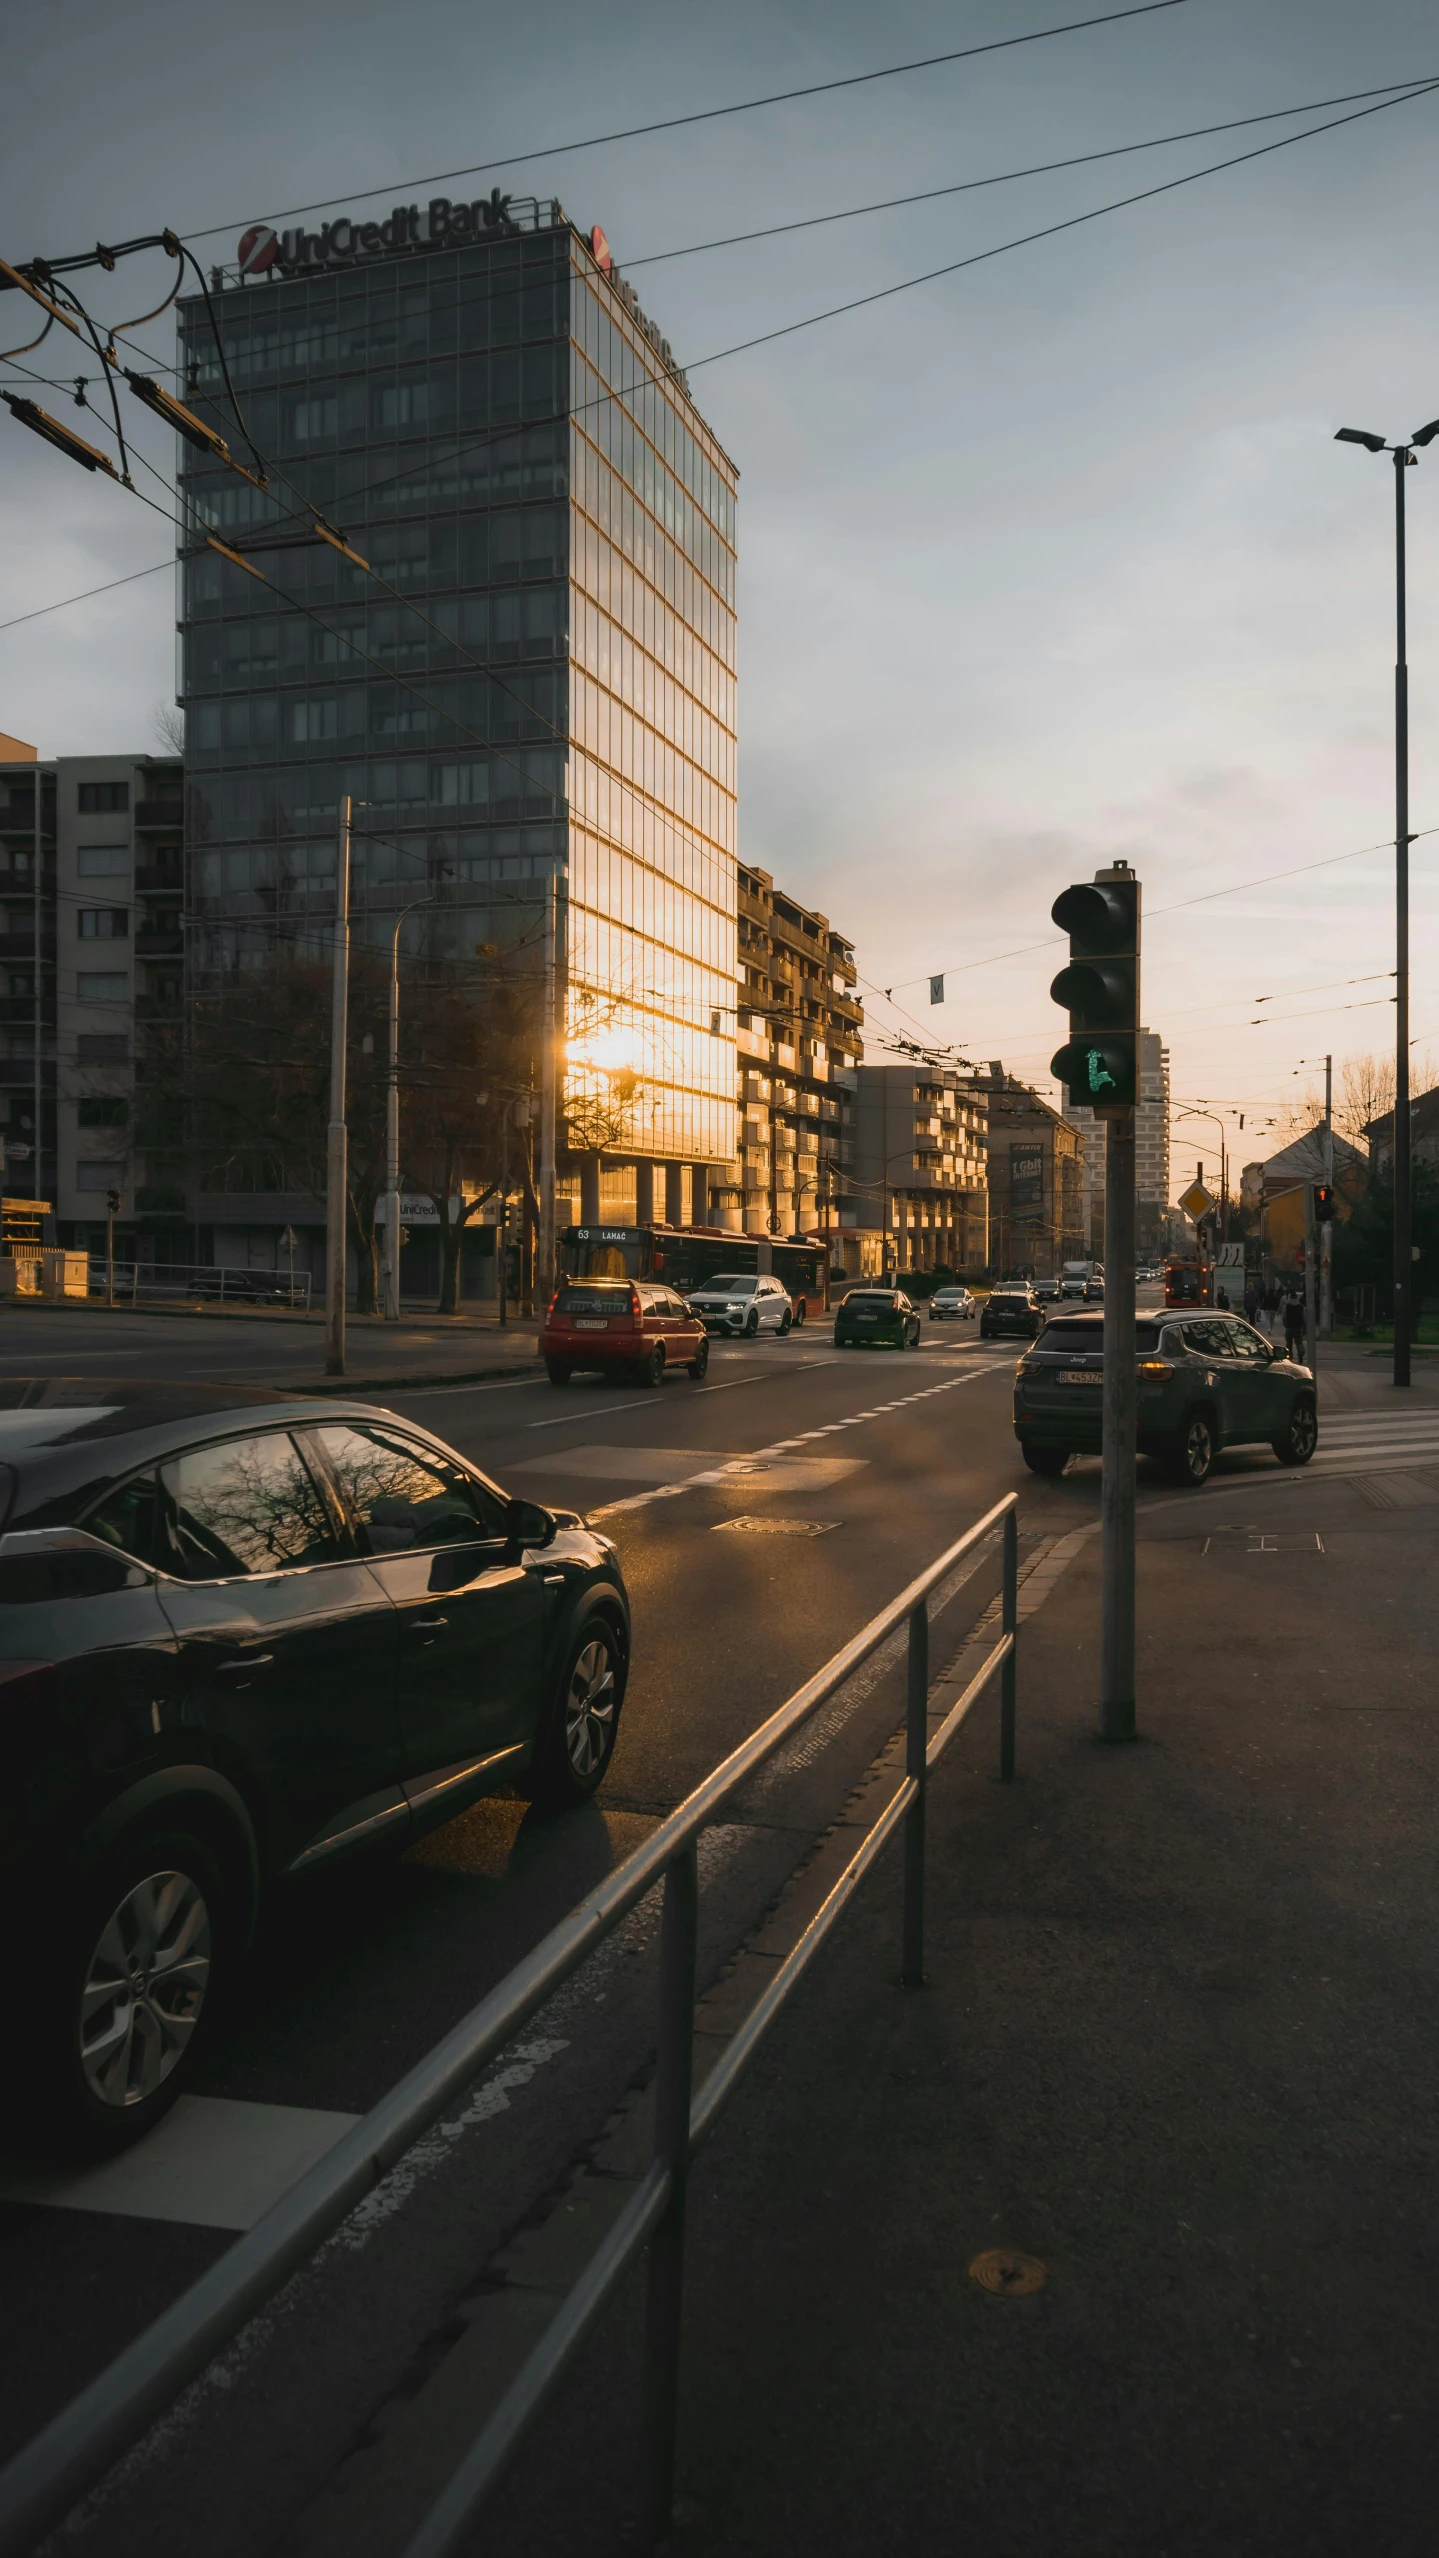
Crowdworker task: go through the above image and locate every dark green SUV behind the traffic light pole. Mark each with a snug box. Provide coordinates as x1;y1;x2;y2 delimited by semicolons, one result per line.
1015;1312;1319;1484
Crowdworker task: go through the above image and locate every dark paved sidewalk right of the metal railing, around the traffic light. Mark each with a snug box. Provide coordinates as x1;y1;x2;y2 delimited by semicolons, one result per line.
473;1476;1439;2558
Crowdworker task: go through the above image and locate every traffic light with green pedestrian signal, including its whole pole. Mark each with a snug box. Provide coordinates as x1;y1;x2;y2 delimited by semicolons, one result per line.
1050;862;1143;1742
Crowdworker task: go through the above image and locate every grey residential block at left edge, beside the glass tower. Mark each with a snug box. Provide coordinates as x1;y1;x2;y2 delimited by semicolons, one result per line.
0;739;187;1261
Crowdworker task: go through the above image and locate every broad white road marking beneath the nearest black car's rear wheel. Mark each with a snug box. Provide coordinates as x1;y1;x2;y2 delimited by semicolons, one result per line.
0;2095;360;2231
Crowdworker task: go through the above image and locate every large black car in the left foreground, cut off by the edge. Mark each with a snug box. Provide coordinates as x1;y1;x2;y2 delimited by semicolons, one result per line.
0;1379;629;2154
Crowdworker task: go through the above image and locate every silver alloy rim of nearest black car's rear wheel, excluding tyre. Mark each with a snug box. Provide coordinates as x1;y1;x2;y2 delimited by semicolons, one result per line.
79;1870;210;2105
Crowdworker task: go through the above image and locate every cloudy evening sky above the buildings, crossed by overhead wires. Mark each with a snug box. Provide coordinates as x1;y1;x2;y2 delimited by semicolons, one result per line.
0;0;1439;1192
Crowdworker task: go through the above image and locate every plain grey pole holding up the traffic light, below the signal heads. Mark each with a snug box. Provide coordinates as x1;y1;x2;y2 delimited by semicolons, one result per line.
1099;1108;1140;1742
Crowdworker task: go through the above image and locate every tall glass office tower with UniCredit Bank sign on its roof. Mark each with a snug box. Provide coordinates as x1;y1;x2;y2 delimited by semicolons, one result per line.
181;200;736;1253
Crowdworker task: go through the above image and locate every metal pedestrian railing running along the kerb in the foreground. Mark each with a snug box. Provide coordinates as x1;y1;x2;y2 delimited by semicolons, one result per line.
0;1491;1020;2558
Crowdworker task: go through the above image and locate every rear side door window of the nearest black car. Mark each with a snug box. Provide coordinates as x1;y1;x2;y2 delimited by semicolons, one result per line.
158;1430;345;1581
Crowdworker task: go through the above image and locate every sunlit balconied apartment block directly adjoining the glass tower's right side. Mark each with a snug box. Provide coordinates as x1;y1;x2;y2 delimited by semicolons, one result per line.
731;865;864;1236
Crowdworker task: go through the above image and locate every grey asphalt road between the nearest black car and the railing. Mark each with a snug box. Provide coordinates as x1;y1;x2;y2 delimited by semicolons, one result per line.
14;1279;1410;2558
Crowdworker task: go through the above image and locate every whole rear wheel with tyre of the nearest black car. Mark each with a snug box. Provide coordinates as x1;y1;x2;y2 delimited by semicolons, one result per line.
20;1832;230;2159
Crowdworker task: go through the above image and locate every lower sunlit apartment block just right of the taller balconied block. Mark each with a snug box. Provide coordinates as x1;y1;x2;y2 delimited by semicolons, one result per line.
843;1062;989;1271
